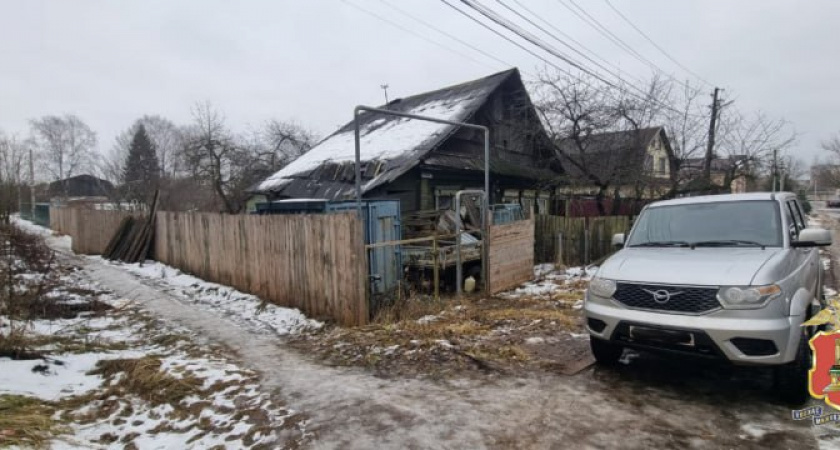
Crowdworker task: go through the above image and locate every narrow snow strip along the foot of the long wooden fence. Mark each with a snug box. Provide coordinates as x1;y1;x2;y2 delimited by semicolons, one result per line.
107;258;323;335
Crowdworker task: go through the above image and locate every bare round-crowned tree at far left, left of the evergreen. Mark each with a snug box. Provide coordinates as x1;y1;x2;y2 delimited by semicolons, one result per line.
30;114;97;192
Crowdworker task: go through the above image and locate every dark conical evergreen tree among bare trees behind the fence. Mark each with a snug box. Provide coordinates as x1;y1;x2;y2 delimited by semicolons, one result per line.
123;123;160;202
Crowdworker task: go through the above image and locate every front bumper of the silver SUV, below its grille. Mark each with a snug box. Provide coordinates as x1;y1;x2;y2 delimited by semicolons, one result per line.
584;299;802;365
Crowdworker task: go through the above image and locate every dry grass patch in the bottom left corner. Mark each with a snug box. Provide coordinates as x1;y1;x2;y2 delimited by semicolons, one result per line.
0;395;67;448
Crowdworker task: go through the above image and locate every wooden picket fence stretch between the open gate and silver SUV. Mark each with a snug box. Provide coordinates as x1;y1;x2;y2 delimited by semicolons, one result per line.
534;216;631;266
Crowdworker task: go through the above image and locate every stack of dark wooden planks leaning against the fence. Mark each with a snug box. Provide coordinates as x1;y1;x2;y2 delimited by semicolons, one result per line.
102;191;160;263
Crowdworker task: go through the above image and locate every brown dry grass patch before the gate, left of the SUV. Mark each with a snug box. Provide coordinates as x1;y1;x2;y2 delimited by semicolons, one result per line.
296;291;585;378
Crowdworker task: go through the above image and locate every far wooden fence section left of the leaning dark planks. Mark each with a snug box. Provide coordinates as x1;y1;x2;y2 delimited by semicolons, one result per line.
50;207;136;255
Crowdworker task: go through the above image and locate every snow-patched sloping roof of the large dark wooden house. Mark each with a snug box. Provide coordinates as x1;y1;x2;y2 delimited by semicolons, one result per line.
251;69;519;198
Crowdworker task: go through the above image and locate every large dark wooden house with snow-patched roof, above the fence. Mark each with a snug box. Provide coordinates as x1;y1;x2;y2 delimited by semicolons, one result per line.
249;69;561;213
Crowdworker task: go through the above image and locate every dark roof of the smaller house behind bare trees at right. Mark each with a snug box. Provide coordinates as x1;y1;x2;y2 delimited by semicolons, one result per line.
558;127;670;181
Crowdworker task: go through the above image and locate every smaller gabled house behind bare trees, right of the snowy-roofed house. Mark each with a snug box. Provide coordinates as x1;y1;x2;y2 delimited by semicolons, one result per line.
558;127;671;199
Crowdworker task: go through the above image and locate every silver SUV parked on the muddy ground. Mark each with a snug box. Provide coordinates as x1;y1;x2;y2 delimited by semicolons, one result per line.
584;193;831;402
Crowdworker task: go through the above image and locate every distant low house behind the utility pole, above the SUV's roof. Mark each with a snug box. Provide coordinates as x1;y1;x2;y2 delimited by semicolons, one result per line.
680;155;750;194
